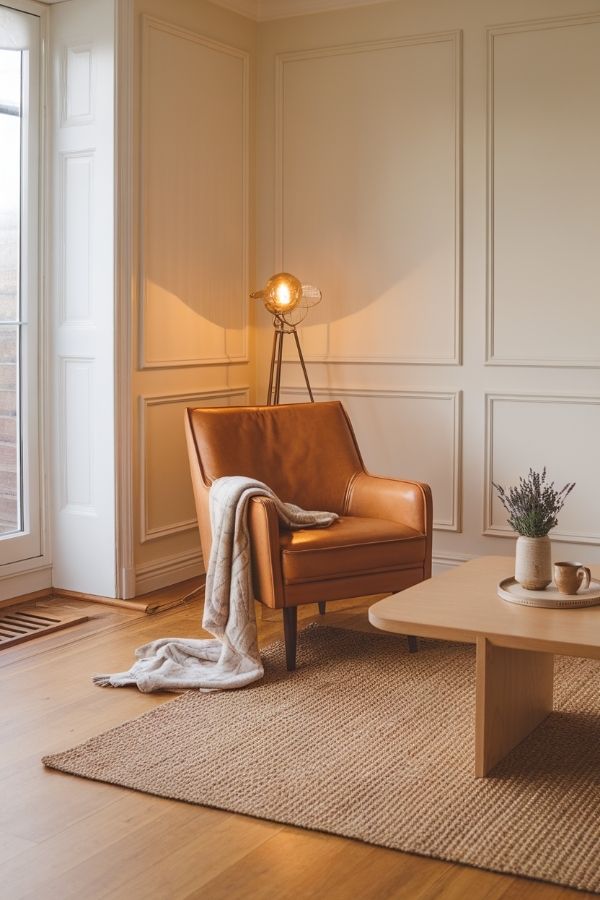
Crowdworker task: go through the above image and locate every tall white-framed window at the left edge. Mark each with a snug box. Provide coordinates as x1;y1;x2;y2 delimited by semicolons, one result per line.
0;5;41;572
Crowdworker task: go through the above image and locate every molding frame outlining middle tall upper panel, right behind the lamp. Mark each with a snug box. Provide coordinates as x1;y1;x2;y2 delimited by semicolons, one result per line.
273;30;463;366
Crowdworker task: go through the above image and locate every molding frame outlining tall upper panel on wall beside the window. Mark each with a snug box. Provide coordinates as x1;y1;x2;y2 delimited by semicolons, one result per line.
137;14;251;369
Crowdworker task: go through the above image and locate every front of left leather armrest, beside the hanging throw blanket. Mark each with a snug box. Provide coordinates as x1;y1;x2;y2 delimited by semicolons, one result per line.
248;497;284;609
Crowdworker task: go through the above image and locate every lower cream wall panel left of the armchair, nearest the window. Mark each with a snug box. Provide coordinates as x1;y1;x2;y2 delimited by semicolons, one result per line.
140;385;249;543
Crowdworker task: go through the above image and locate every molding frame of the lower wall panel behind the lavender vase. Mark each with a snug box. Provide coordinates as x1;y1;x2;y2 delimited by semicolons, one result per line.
482;393;600;545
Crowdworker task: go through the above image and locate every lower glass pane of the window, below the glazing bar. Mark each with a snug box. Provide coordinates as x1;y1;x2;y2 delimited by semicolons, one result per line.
0;325;21;534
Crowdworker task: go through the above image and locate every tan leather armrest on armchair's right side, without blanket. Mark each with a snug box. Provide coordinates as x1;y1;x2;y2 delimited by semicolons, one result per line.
346;472;433;544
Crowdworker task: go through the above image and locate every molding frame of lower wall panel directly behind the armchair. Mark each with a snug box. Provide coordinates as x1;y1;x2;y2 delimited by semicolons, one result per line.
281;387;462;532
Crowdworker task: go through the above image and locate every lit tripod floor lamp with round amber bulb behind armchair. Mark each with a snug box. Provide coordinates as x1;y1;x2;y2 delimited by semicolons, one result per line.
250;272;321;406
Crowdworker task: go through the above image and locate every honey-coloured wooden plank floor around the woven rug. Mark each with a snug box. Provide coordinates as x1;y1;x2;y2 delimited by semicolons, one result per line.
0;584;593;900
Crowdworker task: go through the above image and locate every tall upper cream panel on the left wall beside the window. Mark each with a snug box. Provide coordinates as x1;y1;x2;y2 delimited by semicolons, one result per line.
139;16;250;368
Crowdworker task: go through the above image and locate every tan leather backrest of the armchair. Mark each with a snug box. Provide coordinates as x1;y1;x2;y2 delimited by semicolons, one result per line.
186;401;364;554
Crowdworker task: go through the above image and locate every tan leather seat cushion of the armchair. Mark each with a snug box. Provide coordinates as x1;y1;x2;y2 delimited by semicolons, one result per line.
280;516;426;584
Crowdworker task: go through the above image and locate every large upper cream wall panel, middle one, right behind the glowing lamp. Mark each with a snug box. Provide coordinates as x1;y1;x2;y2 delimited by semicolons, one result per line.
275;31;462;365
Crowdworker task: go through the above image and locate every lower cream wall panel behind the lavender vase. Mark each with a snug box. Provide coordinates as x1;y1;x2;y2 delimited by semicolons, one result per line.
483;393;600;544
